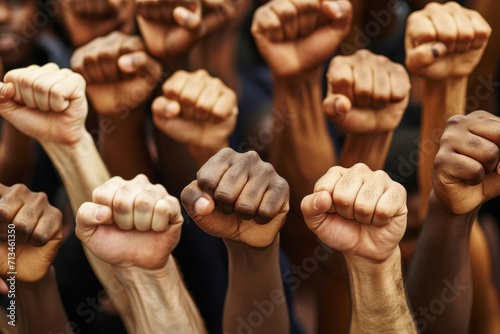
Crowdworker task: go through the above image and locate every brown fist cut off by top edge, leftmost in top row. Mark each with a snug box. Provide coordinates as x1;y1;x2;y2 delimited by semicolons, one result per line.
63;0;135;47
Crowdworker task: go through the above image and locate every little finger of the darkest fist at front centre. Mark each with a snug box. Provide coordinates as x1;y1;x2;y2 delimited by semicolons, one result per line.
254;178;290;225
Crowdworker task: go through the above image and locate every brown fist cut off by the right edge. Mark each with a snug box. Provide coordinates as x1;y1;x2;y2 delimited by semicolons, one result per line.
432;111;500;214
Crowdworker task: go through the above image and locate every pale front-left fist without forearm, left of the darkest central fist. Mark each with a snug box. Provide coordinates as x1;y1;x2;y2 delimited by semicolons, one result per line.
76;174;183;269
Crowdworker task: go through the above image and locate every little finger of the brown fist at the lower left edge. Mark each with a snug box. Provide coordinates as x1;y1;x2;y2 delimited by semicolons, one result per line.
29;207;62;247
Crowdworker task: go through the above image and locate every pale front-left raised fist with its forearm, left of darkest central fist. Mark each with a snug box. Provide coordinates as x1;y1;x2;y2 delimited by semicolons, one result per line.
76;175;205;333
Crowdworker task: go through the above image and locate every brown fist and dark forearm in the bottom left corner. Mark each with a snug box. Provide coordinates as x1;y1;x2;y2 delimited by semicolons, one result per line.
0;184;68;334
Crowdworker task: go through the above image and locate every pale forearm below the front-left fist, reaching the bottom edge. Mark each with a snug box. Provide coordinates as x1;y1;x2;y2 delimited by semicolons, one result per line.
113;256;206;333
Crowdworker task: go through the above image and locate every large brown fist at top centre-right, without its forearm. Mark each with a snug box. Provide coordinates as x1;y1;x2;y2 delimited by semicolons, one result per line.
251;0;352;77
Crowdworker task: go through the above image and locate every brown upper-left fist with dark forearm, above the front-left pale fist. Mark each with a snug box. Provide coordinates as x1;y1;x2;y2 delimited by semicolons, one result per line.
71;31;161;177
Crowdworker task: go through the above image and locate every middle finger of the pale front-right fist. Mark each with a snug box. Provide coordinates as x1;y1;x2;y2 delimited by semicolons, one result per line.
354;171;386;224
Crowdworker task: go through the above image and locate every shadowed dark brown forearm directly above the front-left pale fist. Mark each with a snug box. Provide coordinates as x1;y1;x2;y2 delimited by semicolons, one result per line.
99;110;154;180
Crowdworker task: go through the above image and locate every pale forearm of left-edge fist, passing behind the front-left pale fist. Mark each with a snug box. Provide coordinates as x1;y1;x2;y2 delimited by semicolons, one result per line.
42;133;133;328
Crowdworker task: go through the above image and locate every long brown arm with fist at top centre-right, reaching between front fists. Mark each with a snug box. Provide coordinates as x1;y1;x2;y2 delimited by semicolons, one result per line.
252;1;352;207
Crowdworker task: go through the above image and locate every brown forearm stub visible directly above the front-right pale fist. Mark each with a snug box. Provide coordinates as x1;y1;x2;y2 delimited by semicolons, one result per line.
339;131;393;170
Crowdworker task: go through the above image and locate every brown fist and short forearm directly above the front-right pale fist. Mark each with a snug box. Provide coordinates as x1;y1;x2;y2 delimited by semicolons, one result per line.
323;50;410;169
